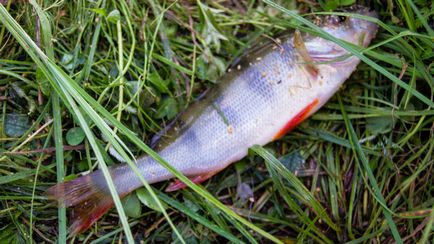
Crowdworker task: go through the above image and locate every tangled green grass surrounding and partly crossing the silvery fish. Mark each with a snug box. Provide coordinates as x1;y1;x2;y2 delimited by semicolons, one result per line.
0;0;434;243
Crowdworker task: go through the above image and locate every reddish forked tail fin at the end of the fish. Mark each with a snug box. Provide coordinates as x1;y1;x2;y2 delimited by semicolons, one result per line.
46;171;117;235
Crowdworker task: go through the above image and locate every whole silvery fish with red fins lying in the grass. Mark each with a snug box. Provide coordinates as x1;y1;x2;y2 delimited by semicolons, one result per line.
48;8;377;234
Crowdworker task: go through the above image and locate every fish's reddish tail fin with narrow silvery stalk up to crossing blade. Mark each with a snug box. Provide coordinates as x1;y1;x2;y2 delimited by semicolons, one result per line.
46;157;173;235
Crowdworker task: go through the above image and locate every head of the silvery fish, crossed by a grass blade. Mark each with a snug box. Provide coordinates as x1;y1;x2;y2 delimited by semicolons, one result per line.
294;6;378;101
